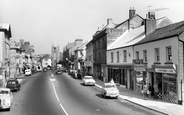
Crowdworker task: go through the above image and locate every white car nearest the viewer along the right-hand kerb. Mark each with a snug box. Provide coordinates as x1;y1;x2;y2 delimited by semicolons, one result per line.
101;82;119;98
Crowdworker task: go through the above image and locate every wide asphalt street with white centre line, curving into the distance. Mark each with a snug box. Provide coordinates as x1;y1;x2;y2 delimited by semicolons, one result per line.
0;70;163;115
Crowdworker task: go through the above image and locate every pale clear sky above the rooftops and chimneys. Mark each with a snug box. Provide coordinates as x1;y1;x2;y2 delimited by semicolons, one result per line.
0;0;184;54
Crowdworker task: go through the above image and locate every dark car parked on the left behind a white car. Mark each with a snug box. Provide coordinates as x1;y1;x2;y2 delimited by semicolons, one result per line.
6;78;21;91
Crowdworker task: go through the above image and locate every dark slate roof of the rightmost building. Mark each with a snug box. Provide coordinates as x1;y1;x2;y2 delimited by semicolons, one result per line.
135;21;184;45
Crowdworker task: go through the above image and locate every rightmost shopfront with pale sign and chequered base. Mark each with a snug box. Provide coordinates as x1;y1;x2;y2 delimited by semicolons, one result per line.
155;66;177;103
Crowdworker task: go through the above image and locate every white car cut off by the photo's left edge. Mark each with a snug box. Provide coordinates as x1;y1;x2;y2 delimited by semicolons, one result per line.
0;88;13;111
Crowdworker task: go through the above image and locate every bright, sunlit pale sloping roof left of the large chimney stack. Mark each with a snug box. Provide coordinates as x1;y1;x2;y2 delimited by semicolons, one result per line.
107;25;145;50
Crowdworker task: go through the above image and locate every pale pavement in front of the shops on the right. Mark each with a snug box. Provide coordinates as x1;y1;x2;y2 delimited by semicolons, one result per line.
95;80;184;115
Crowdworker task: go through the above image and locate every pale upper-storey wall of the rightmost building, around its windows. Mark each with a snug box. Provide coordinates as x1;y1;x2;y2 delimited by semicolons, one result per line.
134;37;178;68
